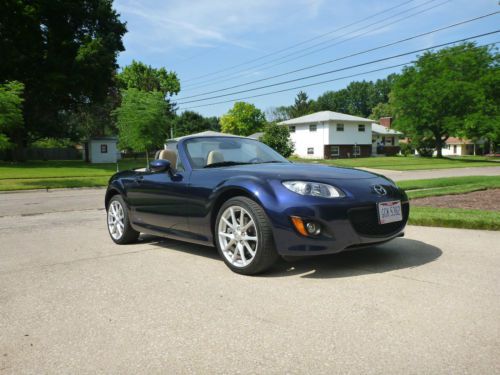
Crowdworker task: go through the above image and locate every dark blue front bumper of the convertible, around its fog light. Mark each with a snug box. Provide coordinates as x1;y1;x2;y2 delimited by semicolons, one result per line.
269;181;410;256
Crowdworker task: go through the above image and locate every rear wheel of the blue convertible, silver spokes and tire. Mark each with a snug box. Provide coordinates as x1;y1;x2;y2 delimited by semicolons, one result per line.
107;195;139;245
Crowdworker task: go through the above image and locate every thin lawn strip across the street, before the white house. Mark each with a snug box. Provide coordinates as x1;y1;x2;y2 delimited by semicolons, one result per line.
290;156;500;171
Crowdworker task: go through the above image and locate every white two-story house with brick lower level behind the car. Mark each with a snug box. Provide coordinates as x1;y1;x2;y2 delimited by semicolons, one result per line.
279;111;373;159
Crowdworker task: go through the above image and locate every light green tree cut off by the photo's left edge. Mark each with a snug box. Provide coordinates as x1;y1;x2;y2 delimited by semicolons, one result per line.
0;81;24;150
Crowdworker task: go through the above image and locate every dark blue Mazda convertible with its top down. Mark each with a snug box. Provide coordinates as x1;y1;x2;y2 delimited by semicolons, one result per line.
105;136;409;275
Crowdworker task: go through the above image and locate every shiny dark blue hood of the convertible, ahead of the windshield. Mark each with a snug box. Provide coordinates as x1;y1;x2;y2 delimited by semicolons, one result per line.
221;163;380;180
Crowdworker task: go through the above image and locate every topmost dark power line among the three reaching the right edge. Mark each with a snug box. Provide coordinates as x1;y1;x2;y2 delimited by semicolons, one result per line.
178;11;500;101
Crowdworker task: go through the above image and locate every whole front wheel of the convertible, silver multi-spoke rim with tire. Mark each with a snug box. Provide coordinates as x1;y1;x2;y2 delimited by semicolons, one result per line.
215;197;279;275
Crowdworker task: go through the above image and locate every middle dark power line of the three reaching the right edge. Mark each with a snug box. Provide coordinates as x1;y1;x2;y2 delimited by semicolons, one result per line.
178;29;500;105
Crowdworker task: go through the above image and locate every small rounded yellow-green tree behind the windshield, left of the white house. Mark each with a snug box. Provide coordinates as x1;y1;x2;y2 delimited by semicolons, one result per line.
220;102;266;136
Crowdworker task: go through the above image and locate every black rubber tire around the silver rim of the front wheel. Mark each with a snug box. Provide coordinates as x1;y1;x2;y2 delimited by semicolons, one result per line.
214;196;279;275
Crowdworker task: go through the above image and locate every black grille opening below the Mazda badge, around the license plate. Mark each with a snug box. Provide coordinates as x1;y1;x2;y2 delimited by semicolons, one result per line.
348;202;410;237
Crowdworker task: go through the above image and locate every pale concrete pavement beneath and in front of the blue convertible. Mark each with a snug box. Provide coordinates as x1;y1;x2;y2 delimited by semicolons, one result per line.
0;190;500;374
